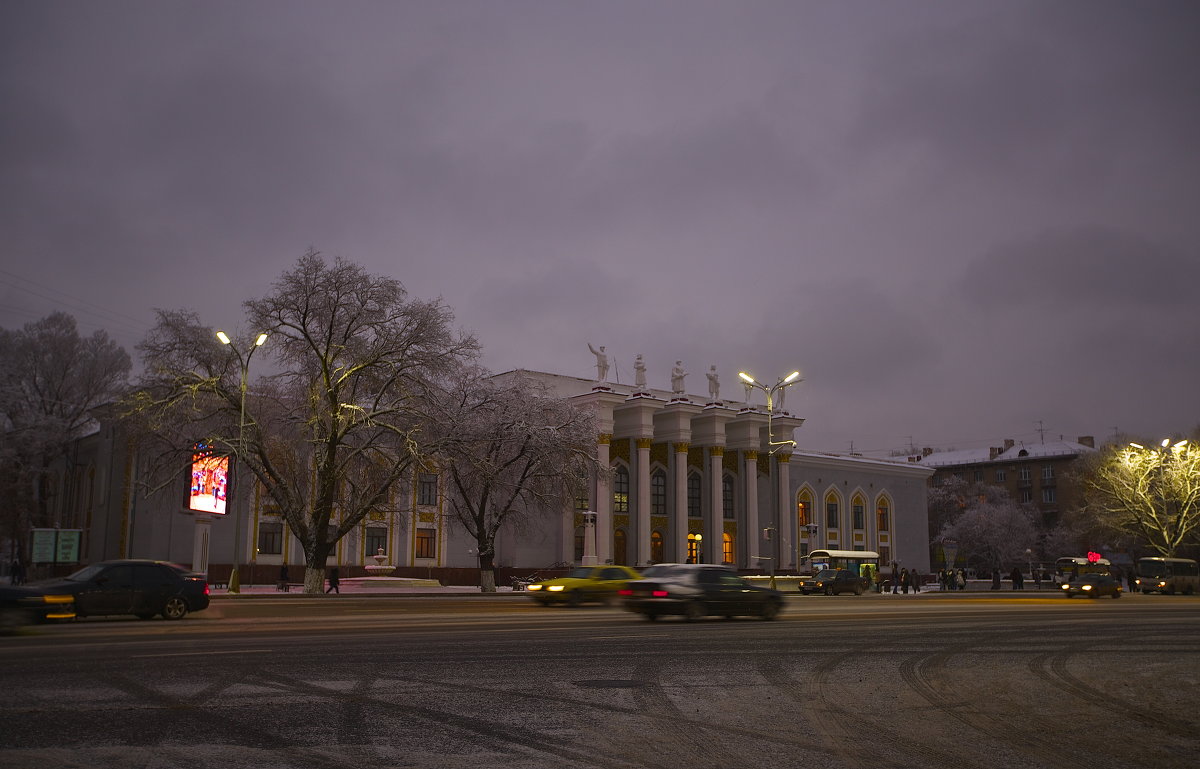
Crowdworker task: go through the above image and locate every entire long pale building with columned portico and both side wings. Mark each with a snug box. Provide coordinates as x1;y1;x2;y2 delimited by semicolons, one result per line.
21;372;934;584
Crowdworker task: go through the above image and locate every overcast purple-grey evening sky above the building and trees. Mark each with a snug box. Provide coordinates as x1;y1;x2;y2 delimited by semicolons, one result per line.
0;0;1200;455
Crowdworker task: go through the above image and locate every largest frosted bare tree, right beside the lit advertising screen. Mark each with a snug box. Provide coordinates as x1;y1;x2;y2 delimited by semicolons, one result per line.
132;251;478;593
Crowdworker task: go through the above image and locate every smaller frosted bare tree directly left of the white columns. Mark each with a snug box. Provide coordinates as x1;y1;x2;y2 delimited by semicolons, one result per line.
434;370;596;593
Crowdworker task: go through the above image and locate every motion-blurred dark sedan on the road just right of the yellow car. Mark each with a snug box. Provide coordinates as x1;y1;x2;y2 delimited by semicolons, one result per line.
620;564;784;621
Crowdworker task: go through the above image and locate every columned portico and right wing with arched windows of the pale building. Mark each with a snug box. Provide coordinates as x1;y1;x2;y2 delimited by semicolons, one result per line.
500;371;932;572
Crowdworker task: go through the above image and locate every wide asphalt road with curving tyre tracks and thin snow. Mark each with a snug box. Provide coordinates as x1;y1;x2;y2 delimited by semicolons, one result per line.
0;595;1200;769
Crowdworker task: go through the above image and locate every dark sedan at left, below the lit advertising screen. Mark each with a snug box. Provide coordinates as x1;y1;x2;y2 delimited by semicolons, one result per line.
30;560;209;619
